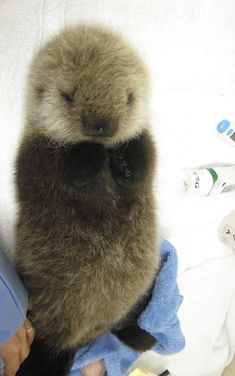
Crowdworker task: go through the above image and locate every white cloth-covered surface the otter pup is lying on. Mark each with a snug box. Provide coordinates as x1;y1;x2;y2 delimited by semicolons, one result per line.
0;0;235;376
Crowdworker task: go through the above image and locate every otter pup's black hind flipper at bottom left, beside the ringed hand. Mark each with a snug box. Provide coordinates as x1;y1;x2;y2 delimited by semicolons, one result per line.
16;338;75;376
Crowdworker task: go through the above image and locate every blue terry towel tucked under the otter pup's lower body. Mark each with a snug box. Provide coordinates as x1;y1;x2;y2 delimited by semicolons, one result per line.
69;240;185;376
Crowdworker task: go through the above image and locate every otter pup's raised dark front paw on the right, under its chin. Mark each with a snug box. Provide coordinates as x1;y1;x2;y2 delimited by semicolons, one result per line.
109;136;148;187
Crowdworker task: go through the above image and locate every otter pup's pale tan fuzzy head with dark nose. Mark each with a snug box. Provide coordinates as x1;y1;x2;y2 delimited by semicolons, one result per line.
27;26;148;146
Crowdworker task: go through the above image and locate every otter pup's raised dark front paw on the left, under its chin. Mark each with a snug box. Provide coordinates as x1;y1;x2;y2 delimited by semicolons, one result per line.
63;142;108;189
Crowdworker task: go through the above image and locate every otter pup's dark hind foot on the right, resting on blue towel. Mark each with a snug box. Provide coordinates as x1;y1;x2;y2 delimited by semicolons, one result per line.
113;324;156;352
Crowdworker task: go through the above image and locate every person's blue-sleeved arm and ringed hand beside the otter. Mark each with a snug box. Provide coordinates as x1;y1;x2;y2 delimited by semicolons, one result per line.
0;249;35;376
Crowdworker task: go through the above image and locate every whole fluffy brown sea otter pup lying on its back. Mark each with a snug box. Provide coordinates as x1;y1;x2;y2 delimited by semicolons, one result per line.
16;25;159;376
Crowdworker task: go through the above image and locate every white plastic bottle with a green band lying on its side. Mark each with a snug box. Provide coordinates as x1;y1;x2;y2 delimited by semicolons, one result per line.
180;165;235;196
